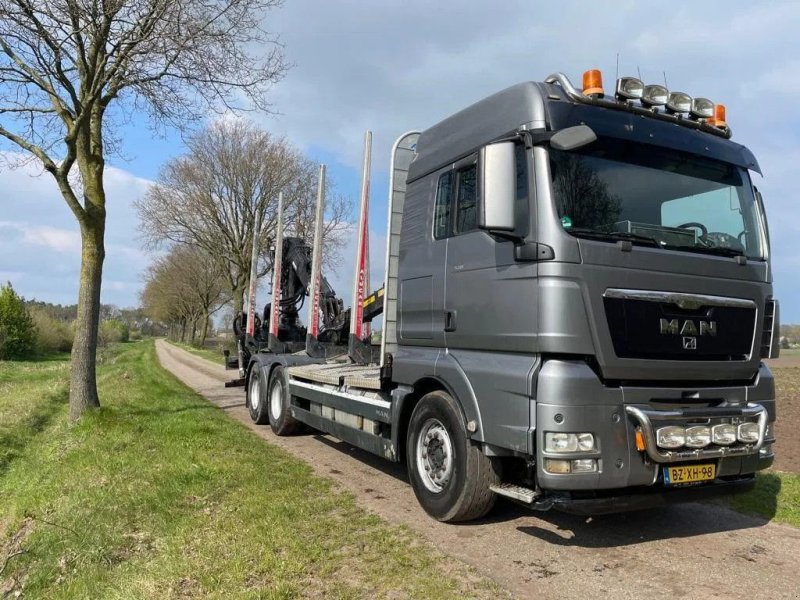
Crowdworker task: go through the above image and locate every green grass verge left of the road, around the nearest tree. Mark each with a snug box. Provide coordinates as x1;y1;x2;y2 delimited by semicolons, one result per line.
0;342;501;598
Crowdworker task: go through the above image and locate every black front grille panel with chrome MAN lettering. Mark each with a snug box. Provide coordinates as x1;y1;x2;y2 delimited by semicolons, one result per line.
603;289;761;361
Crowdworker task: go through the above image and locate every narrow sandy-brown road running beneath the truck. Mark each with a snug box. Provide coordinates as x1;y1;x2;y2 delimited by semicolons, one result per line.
156;340;800;600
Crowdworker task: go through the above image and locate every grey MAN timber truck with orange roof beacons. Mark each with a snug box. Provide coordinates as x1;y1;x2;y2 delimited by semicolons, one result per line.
234;71;779;521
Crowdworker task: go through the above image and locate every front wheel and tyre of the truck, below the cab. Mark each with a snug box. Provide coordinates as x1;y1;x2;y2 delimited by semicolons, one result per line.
406;391;500;522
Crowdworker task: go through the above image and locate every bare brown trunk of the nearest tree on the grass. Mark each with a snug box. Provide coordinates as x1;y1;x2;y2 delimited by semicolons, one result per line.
69;214;105;421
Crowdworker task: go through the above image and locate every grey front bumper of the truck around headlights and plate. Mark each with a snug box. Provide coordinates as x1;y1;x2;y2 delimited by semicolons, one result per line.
530;360;775;492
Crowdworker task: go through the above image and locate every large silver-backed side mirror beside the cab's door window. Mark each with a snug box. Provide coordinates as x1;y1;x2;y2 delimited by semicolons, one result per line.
478;142;517;231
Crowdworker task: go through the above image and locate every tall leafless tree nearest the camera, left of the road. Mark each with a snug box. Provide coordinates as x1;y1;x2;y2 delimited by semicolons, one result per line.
0;0;287;420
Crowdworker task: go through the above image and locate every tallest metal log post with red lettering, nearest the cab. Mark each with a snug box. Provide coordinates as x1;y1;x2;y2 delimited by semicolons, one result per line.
347;130;372;365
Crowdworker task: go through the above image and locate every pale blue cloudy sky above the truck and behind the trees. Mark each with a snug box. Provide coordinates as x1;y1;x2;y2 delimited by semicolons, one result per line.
0;0;800;322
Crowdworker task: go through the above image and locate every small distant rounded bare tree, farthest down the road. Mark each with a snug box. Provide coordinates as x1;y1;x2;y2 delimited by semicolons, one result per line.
141;246;228;346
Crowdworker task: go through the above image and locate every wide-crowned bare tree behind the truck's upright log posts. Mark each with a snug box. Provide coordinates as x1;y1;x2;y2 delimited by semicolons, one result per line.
136;119;349;313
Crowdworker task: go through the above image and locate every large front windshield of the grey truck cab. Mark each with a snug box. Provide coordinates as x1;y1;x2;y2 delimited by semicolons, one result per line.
550;138;764;259
